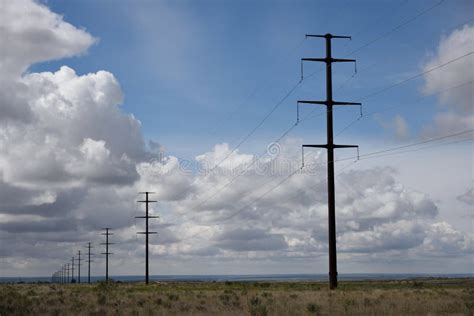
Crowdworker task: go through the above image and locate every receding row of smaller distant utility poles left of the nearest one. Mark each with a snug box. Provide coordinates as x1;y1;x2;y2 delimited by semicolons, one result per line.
51;191;159;284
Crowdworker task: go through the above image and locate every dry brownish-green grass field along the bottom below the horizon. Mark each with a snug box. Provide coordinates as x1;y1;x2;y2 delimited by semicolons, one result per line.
0;279;474;316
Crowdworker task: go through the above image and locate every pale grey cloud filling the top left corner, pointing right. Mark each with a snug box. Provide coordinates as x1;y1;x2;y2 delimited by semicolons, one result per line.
0;0;97;79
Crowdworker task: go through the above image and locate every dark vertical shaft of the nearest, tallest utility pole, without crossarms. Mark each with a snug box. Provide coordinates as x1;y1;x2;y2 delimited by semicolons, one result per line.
326;36;337;289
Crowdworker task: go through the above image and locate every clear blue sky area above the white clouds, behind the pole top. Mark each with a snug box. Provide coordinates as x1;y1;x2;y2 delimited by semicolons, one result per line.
32;0;472;157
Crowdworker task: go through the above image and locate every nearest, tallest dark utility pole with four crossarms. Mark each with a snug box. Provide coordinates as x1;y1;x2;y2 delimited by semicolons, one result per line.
298;34;361;289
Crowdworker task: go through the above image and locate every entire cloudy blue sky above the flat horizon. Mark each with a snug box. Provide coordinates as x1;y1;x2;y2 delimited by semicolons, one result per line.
0;0;474;276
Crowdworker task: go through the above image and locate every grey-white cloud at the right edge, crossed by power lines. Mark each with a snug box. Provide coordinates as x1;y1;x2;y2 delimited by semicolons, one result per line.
423;25;474;135
